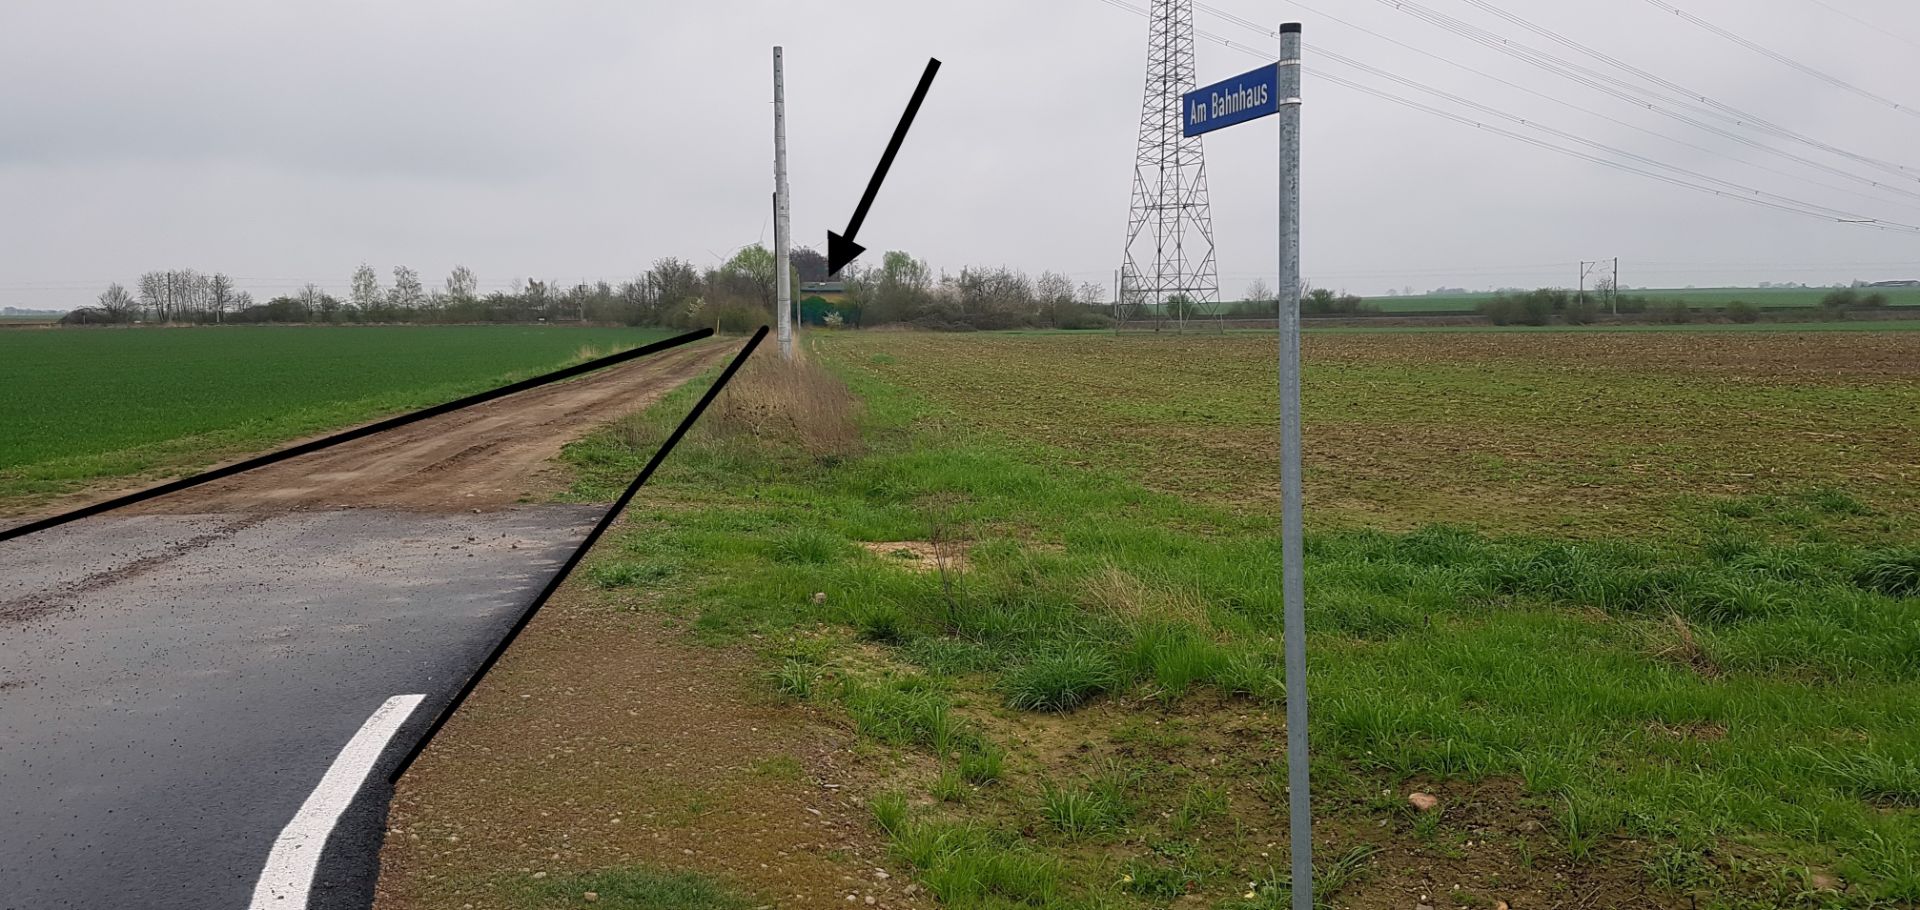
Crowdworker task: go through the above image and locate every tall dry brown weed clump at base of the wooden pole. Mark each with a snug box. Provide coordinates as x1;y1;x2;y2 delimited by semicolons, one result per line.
705;351;860;457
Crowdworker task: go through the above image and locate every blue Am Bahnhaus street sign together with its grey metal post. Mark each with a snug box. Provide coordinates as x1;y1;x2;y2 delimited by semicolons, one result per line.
1181;23;1313;910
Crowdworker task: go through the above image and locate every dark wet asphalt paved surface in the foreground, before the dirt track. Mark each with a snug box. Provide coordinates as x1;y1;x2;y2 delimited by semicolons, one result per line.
0;505;601;910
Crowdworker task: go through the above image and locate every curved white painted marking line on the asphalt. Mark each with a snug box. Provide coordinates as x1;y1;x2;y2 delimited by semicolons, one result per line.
250;695;426;910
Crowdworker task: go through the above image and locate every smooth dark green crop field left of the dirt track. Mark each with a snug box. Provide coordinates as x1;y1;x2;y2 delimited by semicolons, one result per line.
0;326;666;501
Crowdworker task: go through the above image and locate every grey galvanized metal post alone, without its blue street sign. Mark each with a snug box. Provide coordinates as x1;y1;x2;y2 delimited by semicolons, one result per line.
1277;23;1313;910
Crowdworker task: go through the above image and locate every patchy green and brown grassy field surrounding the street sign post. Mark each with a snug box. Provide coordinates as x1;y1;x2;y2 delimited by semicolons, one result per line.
549;332;1920;910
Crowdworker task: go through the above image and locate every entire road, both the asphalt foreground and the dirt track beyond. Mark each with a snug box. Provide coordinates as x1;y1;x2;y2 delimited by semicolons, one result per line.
0;344;732;910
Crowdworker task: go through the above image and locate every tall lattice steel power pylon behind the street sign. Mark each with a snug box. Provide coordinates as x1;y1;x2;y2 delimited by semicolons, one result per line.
1114;0;1219;328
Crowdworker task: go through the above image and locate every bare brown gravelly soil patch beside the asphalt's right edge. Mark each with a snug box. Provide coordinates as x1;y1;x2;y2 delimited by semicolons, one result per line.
374;589;929;910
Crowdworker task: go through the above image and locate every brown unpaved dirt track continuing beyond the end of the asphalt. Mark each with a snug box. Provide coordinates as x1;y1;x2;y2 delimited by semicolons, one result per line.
131;342;733;515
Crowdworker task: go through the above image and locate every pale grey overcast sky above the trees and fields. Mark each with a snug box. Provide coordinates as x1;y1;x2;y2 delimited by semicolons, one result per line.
0;0;1920;307
